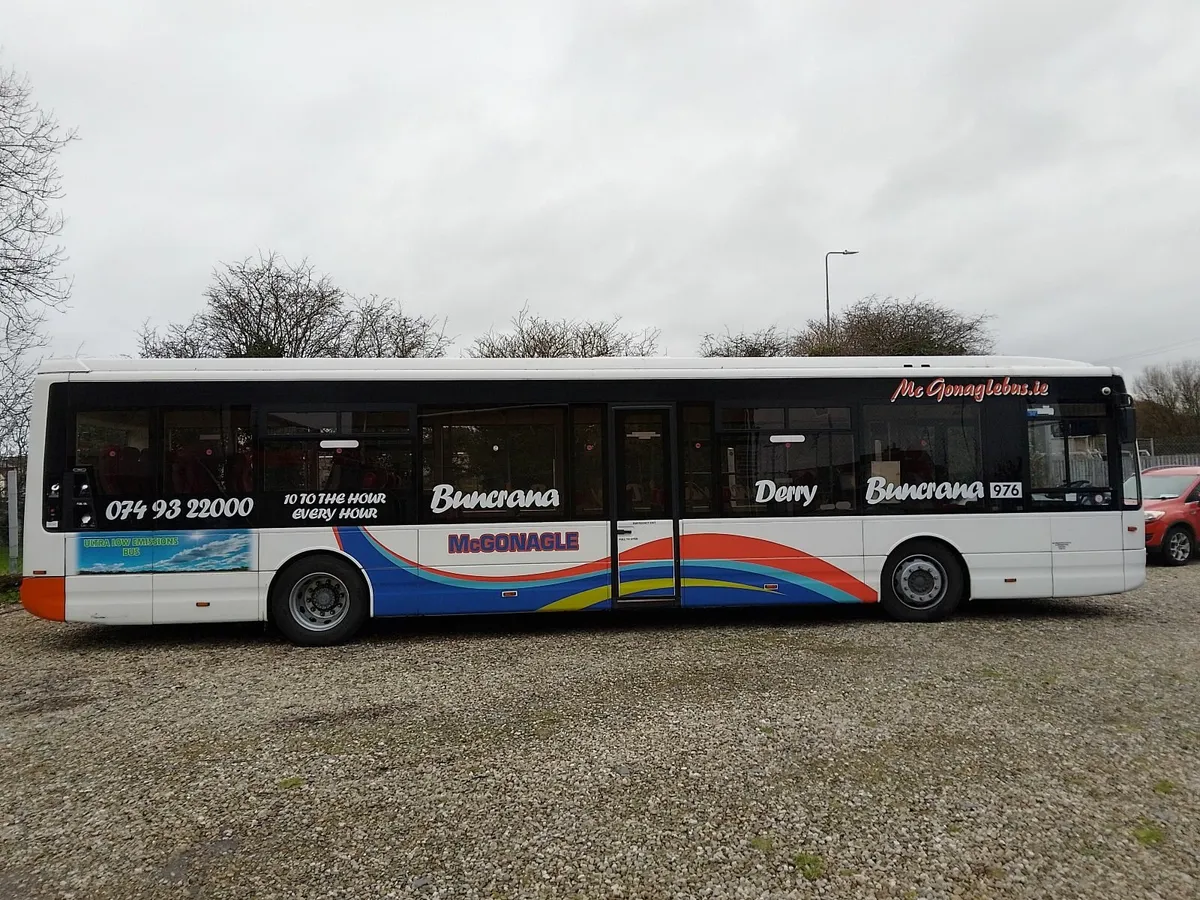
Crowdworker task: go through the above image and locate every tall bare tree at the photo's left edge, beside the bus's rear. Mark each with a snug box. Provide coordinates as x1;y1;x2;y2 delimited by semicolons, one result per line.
0;61;76;472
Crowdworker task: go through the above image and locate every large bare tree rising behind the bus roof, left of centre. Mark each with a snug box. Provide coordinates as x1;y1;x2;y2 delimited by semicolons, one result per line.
139;253;449;359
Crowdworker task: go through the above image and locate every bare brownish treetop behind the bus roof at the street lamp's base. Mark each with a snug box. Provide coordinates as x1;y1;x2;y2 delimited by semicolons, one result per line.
700;295;995;356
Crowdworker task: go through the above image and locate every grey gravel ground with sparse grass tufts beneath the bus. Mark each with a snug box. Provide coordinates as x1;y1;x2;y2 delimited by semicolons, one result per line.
0;565;1200;900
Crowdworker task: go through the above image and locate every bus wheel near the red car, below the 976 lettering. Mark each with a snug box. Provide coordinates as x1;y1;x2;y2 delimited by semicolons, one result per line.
880;540;966;622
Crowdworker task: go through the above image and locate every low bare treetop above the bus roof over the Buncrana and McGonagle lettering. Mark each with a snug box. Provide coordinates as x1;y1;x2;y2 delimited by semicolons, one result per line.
467;306;659;359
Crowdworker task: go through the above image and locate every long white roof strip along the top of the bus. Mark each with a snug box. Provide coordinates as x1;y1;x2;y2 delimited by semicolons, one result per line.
38;356;1121;382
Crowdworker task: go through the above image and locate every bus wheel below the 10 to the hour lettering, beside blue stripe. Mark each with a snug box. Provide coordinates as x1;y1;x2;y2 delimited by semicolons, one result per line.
271;553;371;647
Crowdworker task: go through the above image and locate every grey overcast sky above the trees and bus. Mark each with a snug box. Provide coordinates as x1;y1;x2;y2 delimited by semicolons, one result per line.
0;0;1200;371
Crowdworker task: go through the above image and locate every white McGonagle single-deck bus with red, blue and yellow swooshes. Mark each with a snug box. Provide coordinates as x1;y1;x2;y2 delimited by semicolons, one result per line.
22;356;1146;646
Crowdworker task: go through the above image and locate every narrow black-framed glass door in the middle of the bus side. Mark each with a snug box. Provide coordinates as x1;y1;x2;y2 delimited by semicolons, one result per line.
608;407;679;605
